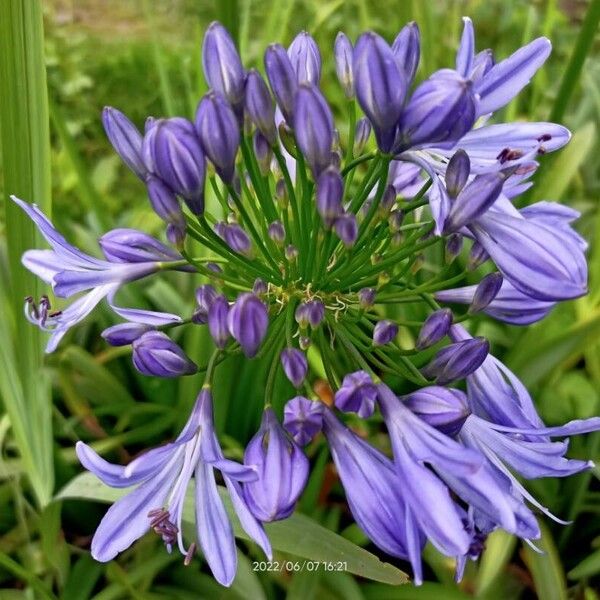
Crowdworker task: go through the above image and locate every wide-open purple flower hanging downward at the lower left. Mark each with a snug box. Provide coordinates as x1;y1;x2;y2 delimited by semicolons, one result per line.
76;388;271;586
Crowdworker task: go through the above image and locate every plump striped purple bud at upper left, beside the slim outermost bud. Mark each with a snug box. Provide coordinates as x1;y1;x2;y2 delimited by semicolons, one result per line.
142;117;206;215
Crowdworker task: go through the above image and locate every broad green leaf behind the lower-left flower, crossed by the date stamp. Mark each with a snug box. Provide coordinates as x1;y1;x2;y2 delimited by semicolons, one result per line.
56;473;408;585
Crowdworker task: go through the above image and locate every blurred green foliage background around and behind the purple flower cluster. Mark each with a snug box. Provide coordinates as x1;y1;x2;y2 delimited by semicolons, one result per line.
0;0;600;600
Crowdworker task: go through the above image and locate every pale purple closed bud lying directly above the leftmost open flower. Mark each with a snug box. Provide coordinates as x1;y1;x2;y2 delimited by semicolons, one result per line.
98;229;181;263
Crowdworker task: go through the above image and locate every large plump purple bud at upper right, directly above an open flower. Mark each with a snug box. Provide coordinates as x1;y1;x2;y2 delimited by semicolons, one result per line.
400;69;477;147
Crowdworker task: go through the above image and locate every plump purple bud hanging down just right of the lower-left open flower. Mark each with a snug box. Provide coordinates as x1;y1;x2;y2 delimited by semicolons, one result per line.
243;408;309;521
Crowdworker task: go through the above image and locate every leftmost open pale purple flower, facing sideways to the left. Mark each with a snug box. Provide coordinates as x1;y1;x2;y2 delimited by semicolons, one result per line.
11;196;176;352
